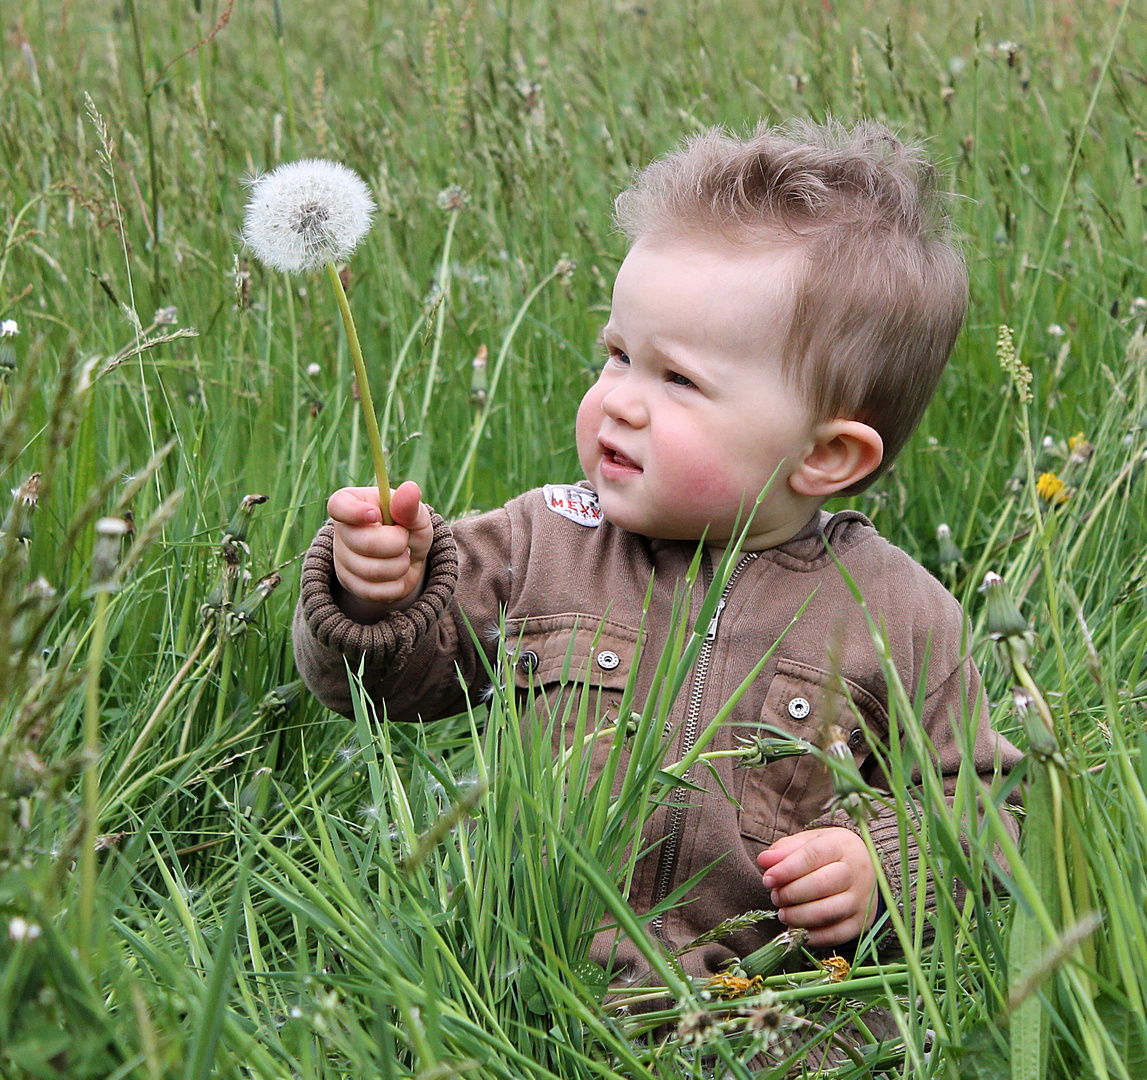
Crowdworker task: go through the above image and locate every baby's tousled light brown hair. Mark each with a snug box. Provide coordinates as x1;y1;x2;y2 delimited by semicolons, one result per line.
615;120;968;494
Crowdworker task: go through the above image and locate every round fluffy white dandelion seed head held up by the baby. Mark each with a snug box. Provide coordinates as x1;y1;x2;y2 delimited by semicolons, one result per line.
243;158;375;274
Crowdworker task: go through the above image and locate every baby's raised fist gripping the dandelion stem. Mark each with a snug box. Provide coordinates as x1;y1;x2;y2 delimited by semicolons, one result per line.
327;480;434;623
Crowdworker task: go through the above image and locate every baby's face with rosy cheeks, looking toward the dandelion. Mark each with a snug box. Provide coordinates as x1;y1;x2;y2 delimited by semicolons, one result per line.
577;240;817;549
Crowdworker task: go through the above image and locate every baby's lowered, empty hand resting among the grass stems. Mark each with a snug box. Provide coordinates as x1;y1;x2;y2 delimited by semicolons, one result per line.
757;828;876;948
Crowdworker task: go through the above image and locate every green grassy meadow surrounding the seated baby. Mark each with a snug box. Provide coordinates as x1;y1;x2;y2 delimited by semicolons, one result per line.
0;0;1147;1080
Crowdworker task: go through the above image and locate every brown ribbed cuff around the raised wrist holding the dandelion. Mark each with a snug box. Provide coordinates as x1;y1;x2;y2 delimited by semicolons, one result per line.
299;512;458;667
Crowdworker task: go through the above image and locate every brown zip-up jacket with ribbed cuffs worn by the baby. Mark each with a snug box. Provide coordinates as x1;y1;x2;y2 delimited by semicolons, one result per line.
294;485;1020;977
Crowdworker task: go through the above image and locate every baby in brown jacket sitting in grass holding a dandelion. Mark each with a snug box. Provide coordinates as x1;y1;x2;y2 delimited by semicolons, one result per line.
295;123;1019;977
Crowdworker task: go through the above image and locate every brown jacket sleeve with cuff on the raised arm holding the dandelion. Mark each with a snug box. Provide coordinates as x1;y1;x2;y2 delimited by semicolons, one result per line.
292;511;509;721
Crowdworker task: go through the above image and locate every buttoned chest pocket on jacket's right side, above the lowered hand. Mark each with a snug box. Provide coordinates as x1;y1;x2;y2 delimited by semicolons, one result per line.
741;659;888;845
